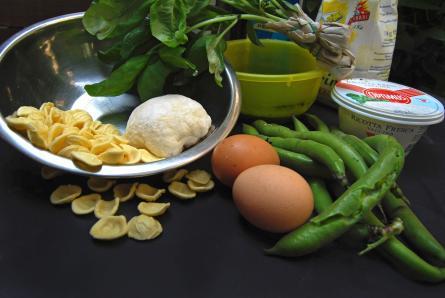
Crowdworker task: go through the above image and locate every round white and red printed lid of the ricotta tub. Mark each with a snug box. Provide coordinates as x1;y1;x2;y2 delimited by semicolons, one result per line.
331;79;444;125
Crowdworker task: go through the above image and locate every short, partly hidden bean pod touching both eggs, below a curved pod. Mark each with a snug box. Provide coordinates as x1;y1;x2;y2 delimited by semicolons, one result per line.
274;147;331;178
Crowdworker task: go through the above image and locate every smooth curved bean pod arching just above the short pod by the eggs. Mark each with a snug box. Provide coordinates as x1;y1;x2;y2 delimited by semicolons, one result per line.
268;137;348;185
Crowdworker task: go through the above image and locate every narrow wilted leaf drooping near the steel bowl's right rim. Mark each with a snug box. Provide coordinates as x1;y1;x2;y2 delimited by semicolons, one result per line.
206;35;226;87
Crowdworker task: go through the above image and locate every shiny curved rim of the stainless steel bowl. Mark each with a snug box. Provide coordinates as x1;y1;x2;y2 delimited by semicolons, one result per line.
0;12;241;178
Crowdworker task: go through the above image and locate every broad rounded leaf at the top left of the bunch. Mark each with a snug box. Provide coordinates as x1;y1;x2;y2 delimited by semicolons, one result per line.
82;0;154;40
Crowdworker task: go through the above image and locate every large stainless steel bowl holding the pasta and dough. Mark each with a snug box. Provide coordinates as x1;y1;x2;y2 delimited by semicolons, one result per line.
0;13;241;178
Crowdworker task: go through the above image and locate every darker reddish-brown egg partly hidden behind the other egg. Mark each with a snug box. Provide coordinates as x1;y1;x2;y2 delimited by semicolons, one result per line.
212;134;280;186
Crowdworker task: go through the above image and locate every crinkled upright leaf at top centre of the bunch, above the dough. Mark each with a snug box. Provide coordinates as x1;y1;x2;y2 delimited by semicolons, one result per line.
150;0;188;48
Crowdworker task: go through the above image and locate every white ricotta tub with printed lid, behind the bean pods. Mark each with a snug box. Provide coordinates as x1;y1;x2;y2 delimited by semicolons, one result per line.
331;79;444;154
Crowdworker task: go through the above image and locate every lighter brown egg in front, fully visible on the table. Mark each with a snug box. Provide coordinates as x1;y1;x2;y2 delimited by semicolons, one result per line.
232;165;314;233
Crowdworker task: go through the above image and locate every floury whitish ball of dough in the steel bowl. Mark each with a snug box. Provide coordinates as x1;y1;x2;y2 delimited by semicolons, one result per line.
126;94;212;157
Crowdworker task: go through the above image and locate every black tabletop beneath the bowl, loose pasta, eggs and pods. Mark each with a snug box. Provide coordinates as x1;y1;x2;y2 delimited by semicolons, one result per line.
0;103;445;298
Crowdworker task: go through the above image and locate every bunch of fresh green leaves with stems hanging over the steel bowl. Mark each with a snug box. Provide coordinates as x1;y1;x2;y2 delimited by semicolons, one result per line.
82;0;292;100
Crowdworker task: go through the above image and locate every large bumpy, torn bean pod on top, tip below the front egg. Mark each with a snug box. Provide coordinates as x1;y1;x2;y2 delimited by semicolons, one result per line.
266;136;405;256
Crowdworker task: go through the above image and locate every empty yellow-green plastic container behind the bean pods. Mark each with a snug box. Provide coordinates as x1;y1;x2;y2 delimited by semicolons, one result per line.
225;39;323;118
